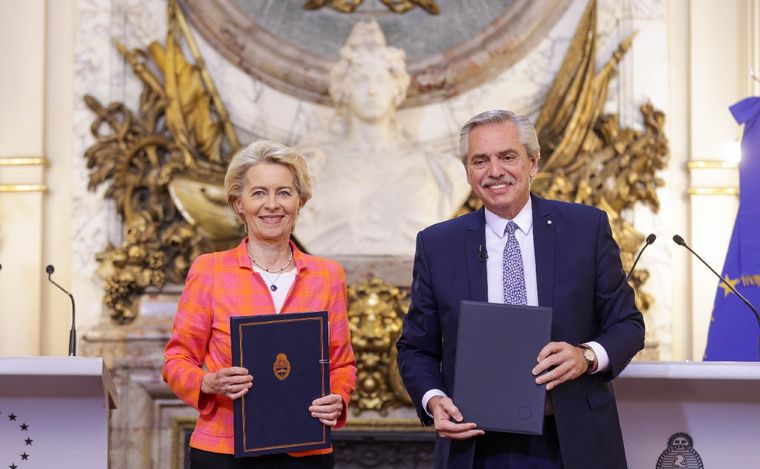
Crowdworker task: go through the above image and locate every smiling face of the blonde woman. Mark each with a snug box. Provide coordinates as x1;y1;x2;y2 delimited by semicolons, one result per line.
235;163;301;241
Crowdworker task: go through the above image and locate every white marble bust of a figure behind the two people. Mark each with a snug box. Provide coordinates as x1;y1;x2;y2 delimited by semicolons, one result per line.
295;21;470;257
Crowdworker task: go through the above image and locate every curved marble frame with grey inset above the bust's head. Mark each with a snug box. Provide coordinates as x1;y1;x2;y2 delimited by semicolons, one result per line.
182;0;569;106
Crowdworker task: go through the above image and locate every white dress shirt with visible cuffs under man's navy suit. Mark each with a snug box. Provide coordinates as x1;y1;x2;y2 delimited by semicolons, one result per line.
422;198;610;417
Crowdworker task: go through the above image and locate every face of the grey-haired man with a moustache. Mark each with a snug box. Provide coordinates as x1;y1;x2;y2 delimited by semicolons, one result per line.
466;122;538;220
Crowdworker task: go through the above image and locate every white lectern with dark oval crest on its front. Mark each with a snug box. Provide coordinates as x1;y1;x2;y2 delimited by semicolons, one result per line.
613;362;760;469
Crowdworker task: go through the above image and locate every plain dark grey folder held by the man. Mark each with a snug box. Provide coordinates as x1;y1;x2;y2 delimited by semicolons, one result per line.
452;301;552;435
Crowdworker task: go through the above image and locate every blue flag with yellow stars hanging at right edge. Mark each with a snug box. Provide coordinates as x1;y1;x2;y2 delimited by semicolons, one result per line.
704;97;760;361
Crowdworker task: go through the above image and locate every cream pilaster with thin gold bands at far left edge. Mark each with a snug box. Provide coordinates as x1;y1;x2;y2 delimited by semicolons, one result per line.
0;0;45;355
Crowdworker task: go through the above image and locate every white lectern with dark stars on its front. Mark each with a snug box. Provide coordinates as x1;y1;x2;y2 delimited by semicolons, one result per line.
0;357;116;469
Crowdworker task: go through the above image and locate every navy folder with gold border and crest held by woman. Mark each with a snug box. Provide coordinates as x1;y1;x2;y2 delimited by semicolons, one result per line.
230;311;330;457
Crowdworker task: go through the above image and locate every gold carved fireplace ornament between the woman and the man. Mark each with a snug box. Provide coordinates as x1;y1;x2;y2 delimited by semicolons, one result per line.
348;278;412;415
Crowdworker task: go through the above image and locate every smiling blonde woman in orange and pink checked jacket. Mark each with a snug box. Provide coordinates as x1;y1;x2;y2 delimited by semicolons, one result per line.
163;140;356;469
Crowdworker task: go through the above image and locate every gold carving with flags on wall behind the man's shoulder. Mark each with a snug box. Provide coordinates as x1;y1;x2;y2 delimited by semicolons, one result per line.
459;1;669;359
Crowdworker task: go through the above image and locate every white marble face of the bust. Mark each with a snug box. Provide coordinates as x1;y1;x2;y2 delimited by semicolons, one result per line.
348;58;399;122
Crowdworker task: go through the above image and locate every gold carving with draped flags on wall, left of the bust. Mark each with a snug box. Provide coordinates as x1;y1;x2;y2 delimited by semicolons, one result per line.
84;1;240;324
